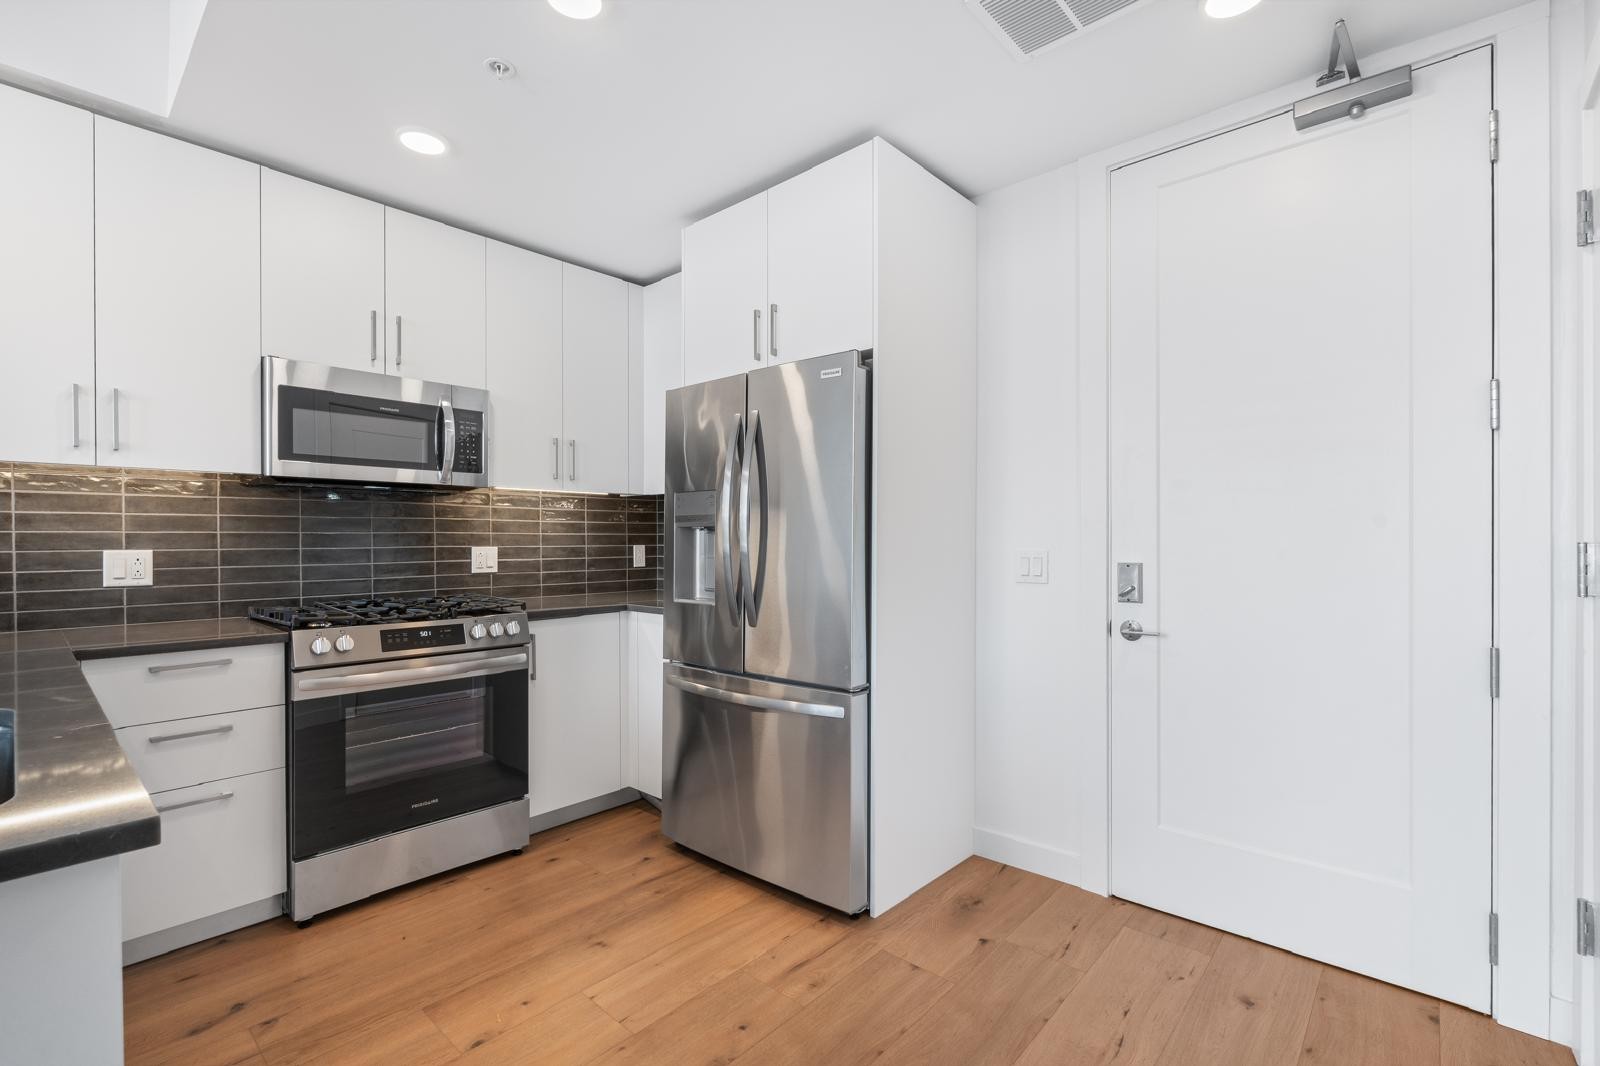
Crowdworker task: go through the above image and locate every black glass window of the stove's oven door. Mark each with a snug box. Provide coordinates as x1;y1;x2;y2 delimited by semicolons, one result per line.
290;669;528;860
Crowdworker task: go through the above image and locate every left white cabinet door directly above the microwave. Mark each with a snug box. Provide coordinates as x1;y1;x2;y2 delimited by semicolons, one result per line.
261;170;386;373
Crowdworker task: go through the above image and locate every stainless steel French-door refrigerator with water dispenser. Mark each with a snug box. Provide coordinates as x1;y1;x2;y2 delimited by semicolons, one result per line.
661;344;870;914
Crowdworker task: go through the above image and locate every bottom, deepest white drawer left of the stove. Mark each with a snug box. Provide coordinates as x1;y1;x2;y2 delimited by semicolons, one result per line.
122;770;286;940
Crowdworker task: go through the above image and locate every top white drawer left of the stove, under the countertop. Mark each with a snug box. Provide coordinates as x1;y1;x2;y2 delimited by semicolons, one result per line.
83;633;283;728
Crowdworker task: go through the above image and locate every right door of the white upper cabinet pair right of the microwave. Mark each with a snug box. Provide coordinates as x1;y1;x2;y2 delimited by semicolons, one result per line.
562;262;629;493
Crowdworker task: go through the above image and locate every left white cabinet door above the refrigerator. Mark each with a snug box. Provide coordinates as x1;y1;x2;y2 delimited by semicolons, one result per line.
683;192;766;381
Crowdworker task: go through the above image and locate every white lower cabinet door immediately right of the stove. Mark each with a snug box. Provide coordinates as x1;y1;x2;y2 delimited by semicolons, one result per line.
528;613;624;818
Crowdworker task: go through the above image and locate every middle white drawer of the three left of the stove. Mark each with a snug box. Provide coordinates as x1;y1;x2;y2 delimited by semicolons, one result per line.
117;707;283;792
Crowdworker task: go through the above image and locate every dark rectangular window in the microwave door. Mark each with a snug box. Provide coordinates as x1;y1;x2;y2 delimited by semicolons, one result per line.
277;386;443;471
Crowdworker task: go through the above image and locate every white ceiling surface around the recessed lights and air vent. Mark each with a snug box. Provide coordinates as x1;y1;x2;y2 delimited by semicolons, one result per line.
18;0;1518;280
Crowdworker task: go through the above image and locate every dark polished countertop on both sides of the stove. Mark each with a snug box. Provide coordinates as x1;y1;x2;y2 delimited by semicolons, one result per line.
0;594;661;880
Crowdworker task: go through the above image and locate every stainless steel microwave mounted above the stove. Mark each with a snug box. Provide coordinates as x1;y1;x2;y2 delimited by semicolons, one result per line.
261;355;490;488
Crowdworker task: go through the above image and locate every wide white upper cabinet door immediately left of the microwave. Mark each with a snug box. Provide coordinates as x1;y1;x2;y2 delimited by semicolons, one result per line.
94;118;261;472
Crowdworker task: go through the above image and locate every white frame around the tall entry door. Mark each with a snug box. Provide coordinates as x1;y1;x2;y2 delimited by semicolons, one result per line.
1067;0;1573;1039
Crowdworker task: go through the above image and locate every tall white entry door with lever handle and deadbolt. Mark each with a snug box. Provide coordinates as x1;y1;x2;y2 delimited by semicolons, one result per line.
1109;50;1493;1010
